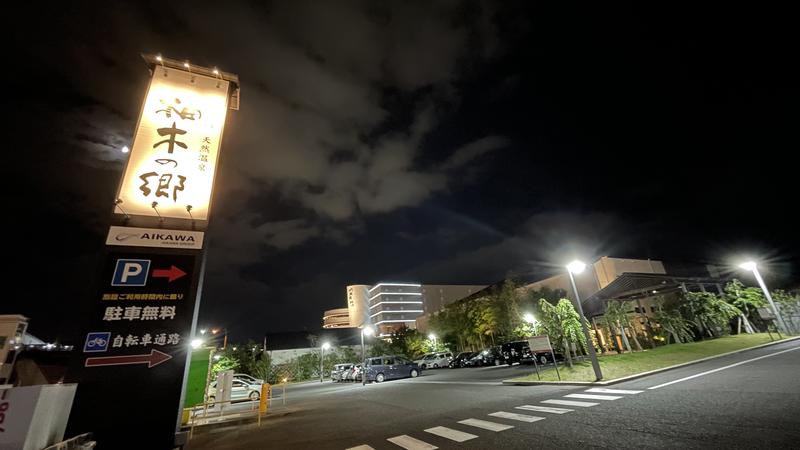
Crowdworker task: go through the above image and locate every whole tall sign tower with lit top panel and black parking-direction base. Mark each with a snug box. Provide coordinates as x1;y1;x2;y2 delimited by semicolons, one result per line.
69;56;239;449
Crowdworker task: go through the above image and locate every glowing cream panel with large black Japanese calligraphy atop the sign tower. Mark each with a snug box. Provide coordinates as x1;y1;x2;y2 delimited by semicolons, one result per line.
118;67;228;220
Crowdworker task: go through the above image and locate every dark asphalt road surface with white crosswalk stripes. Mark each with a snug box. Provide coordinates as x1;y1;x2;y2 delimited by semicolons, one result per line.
188;341;800;450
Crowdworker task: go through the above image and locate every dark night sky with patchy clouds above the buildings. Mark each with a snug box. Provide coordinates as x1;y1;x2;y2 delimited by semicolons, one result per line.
7;1;800;340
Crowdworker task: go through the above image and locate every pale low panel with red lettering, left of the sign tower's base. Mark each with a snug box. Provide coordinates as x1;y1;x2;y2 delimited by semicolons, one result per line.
0;384;78;450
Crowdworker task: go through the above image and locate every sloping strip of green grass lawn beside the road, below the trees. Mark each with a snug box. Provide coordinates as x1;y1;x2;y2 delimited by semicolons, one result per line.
510;333;777;381
